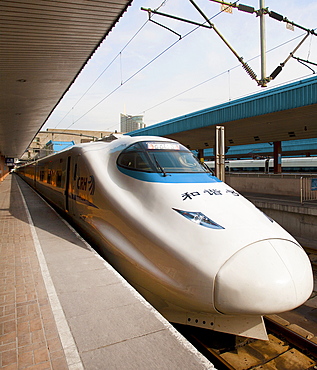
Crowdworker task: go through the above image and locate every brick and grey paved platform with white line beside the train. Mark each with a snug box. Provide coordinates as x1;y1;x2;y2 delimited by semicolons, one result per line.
0;174;214;370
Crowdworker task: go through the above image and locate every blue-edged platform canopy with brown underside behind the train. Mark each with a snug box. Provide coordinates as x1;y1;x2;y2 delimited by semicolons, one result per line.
129;76;317;150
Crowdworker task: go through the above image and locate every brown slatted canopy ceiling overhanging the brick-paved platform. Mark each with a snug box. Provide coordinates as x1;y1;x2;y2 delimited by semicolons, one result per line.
0;0;132;157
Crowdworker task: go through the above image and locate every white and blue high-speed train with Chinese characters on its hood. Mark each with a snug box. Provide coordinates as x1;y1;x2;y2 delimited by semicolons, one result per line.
16;136;313;339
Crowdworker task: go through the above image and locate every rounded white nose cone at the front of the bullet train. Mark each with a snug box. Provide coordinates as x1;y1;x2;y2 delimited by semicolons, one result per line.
214;239;313;315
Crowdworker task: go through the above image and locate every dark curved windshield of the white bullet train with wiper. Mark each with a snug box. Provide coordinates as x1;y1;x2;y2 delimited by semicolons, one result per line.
117;141;209;175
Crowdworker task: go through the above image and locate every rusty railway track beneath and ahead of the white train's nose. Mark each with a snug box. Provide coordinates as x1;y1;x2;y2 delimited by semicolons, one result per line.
175;318;317;370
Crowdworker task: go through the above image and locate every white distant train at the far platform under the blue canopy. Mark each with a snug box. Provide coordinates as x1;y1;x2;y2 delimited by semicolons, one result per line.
205;157;317;173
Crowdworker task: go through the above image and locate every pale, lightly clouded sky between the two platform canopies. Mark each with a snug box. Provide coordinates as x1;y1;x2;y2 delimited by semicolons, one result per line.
42;0;317;132
